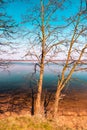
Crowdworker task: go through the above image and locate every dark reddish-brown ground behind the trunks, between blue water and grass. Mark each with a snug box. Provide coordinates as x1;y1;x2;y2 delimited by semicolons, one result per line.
0;88;87;116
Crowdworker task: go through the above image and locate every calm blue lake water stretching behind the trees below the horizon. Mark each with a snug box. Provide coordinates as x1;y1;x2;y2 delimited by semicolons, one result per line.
0;62;87;92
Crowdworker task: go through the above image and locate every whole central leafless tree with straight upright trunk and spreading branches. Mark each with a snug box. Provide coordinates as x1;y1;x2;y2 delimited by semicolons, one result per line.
22;0;72;115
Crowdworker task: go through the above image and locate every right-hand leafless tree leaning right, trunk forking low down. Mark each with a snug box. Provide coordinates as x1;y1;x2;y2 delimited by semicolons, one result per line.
54;1;87;117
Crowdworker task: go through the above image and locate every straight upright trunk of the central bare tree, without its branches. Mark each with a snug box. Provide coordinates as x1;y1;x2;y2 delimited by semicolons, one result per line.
35;0;45;115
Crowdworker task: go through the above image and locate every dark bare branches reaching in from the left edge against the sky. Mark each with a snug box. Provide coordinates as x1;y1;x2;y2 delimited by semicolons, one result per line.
0;0;17;68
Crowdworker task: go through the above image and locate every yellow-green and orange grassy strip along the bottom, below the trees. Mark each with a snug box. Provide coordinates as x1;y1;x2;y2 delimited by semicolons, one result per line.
0;115;87;130
